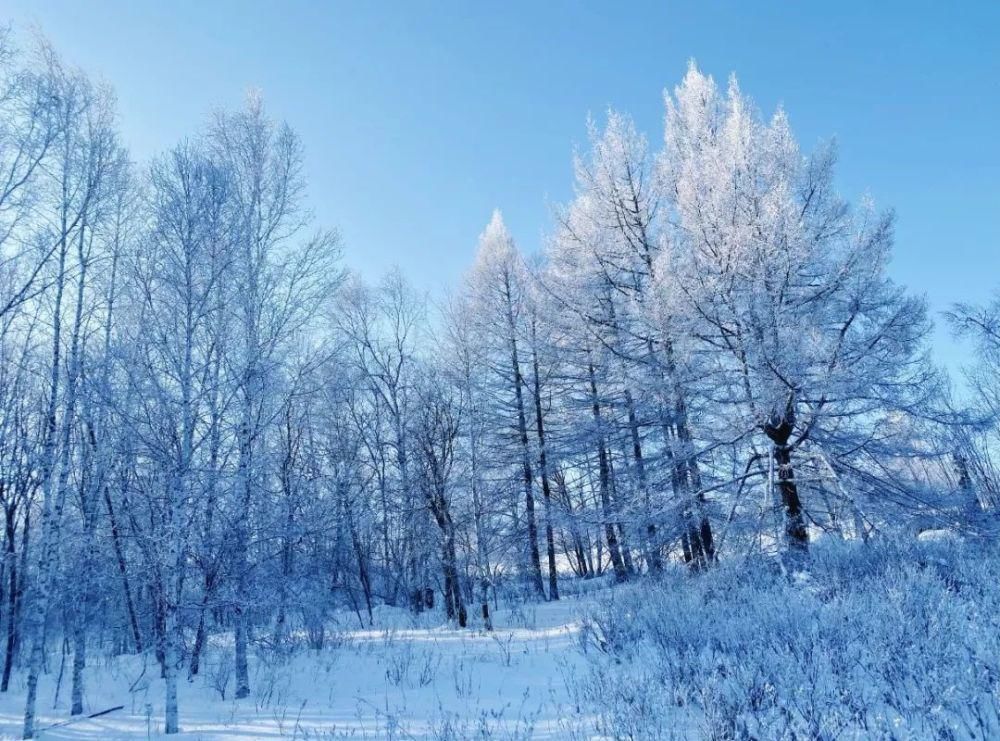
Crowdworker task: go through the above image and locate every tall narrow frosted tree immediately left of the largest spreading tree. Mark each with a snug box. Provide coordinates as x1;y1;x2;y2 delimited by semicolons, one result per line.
549;112;714;570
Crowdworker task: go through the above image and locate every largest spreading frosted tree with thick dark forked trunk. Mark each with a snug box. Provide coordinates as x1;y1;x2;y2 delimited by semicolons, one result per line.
658;66;937;548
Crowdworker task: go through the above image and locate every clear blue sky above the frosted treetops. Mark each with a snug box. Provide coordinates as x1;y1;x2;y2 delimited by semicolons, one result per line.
0;0;1000;365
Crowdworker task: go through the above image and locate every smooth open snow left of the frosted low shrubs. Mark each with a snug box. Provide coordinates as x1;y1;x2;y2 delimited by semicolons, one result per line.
0;598;587;739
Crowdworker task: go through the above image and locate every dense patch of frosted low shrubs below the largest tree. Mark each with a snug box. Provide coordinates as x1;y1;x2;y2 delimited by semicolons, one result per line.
577;542;1000;739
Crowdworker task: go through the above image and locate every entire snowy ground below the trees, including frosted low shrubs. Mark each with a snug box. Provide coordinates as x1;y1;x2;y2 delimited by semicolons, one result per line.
0;537;1000;741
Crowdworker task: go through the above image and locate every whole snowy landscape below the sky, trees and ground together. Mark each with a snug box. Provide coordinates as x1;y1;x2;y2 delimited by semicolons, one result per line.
0;24;1000;739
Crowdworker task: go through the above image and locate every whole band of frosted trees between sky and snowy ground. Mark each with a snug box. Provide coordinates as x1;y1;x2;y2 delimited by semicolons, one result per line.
0;23;980;738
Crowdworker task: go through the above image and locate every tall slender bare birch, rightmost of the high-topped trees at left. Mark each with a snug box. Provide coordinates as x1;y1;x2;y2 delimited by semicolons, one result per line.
209;93;339;697
